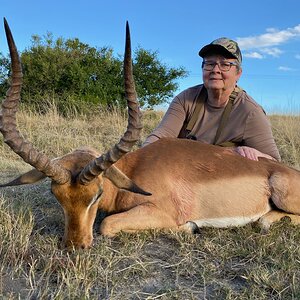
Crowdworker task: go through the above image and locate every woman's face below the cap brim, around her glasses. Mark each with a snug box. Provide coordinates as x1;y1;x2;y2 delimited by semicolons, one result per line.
202;55;242;91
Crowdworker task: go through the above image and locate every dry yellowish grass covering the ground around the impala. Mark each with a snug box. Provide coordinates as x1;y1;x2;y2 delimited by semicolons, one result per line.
0;109;300;299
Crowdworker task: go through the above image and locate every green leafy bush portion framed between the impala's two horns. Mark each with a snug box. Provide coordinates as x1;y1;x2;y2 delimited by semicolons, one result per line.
21;33;122;111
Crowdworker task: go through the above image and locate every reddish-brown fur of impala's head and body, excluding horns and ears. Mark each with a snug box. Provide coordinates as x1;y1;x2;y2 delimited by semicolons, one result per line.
4;139;300;248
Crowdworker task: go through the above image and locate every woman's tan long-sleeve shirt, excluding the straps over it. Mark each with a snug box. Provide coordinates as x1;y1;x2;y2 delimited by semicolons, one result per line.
144;85;280;160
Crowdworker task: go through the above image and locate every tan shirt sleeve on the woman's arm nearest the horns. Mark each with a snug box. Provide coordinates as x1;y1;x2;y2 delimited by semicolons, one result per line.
142;92;186;147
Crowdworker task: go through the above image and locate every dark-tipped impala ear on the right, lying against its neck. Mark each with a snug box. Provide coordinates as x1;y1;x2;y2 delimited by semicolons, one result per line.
103;165;152;196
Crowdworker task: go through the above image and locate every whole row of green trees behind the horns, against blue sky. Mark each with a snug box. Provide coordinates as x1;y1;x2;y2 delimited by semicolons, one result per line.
0;33;187;113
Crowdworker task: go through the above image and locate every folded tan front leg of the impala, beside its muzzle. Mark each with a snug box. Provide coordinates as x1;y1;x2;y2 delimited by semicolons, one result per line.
100;203;177;236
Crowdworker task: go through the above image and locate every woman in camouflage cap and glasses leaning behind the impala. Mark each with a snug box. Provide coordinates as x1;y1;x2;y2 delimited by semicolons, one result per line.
143;38;280;160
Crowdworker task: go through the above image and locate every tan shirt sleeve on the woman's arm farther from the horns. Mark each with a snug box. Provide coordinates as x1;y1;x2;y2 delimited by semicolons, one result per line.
244;108;281;161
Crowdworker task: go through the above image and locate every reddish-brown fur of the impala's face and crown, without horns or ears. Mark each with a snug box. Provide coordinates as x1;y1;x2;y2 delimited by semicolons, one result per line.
51;148;102;248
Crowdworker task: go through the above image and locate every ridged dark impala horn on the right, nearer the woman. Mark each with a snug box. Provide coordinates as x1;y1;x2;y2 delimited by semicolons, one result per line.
78;22;142;185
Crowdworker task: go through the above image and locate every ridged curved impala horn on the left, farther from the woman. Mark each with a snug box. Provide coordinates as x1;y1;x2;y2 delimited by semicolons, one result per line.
0;18;71;184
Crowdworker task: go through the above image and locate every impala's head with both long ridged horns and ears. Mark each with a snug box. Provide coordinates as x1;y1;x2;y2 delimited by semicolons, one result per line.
0;19;147;248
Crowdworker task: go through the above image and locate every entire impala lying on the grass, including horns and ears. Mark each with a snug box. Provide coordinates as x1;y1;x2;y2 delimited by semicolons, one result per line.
0;21;300;248
